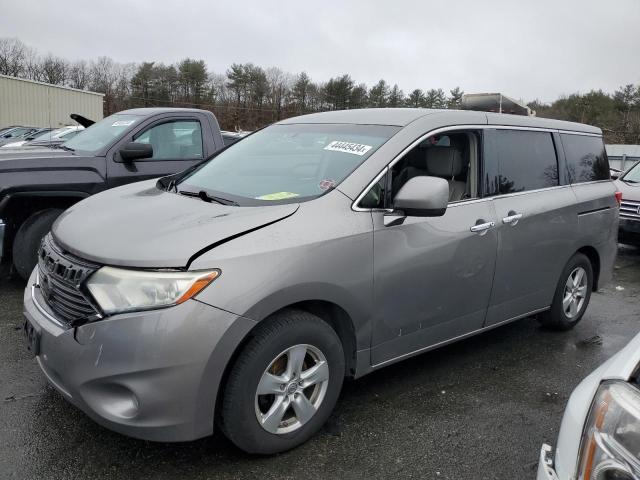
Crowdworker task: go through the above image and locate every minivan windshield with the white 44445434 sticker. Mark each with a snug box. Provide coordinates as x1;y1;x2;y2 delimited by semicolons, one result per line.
180;124;400;205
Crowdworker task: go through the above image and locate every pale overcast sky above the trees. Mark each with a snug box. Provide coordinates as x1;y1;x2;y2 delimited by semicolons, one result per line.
0;0;640;102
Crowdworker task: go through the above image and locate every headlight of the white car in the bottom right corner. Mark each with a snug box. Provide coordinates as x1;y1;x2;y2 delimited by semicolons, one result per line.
578;382;640;480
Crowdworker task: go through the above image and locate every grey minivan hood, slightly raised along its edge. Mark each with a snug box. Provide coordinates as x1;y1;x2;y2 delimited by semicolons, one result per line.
51;180;298;268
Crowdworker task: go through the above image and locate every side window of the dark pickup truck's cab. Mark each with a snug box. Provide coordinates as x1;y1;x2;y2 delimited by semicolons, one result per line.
134;120;202;160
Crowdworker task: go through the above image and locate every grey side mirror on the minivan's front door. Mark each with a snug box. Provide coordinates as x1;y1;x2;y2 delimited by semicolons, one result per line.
385;176;449;226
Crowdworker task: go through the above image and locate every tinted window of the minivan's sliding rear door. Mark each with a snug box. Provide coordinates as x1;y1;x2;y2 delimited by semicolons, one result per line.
482;130;558;196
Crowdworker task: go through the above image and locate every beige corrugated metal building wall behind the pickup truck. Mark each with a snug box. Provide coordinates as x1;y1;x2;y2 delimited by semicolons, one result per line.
0;75;104;128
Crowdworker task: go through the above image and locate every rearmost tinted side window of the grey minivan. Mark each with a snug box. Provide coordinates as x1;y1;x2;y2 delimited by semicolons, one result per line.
560;133;610;183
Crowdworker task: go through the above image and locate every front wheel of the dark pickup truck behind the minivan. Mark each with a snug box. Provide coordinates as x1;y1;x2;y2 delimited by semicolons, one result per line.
13;208;63;280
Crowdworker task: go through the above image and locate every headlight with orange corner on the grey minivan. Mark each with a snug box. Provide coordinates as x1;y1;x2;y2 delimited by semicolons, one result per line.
87;267;220;314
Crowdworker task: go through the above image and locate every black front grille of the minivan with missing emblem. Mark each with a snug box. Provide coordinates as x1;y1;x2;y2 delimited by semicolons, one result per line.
38;234;100;325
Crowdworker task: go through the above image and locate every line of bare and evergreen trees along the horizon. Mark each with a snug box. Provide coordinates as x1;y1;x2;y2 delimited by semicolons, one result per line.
0;38;640;143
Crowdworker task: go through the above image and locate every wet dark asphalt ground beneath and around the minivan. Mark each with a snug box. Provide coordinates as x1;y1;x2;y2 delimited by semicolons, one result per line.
0;247;640;480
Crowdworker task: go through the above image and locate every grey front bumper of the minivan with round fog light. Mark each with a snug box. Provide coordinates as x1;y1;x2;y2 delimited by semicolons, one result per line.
24;268;255;442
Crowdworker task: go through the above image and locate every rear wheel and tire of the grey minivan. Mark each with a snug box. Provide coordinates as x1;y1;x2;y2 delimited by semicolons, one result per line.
538;253;593;331
